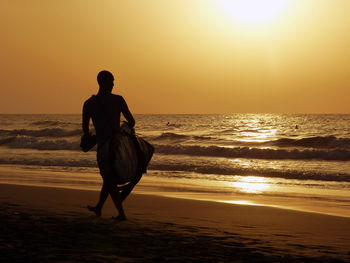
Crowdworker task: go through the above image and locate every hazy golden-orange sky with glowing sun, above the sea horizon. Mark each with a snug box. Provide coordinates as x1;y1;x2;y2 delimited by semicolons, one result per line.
0;0;350;113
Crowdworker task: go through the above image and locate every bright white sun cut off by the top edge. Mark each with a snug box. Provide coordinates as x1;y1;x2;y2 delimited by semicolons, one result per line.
219;0;288;24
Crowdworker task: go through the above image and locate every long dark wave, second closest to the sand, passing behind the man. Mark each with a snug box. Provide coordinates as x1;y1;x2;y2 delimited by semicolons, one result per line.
0;136;350;161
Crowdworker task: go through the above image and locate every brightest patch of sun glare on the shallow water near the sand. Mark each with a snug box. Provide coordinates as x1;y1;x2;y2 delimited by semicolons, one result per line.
231;176;270;193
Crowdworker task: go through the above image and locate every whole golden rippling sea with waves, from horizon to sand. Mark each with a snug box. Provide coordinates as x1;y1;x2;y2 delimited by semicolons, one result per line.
0;114;350;217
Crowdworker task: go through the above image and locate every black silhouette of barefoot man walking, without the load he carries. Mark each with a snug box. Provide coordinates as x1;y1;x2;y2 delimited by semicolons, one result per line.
83;70;135;221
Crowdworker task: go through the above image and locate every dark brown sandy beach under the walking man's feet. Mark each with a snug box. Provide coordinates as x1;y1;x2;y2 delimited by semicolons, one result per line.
0;184;350;262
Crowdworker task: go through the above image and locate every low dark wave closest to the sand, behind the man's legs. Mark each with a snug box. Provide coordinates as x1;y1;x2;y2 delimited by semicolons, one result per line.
0;155;350;182
